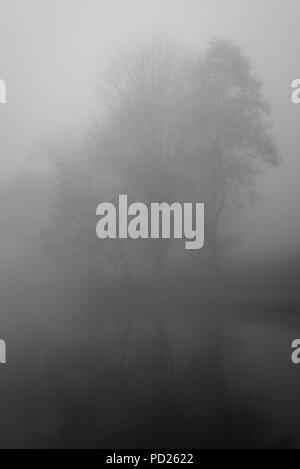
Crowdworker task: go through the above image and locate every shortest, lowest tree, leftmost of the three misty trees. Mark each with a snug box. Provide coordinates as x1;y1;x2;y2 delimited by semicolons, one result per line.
42;132;128;281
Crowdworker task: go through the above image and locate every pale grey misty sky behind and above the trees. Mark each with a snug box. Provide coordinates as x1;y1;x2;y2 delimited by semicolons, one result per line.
0;0;300;253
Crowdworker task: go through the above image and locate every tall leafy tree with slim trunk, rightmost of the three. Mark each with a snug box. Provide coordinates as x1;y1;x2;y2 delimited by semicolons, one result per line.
189;39;280;269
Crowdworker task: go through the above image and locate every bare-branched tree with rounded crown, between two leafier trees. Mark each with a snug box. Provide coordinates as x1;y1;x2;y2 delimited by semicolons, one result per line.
96;42;187;275
